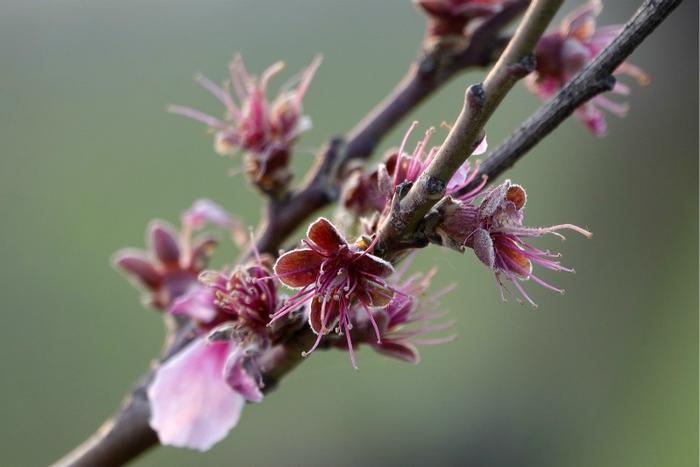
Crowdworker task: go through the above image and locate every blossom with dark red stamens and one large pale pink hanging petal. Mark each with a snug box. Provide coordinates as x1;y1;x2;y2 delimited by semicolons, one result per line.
148;252;279;450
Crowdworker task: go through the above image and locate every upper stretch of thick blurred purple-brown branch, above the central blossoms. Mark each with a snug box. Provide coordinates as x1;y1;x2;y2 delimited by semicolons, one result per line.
257;0;530;255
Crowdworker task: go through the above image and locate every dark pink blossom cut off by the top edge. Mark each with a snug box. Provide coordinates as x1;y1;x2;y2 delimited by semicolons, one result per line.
415;0;503;36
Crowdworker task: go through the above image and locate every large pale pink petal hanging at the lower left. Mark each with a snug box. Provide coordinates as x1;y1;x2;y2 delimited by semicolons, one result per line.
148;337;245;451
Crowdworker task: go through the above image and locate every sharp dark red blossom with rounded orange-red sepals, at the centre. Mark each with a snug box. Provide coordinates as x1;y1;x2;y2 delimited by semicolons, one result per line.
271;217;394;368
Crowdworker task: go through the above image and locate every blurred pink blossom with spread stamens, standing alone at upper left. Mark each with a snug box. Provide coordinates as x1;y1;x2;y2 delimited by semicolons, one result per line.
169;56;321;191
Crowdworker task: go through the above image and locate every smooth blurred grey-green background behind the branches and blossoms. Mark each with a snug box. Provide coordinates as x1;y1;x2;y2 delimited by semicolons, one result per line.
0;0;698;467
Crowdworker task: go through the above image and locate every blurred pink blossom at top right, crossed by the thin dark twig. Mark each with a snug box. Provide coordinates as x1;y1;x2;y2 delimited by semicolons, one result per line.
525;0;649;136
